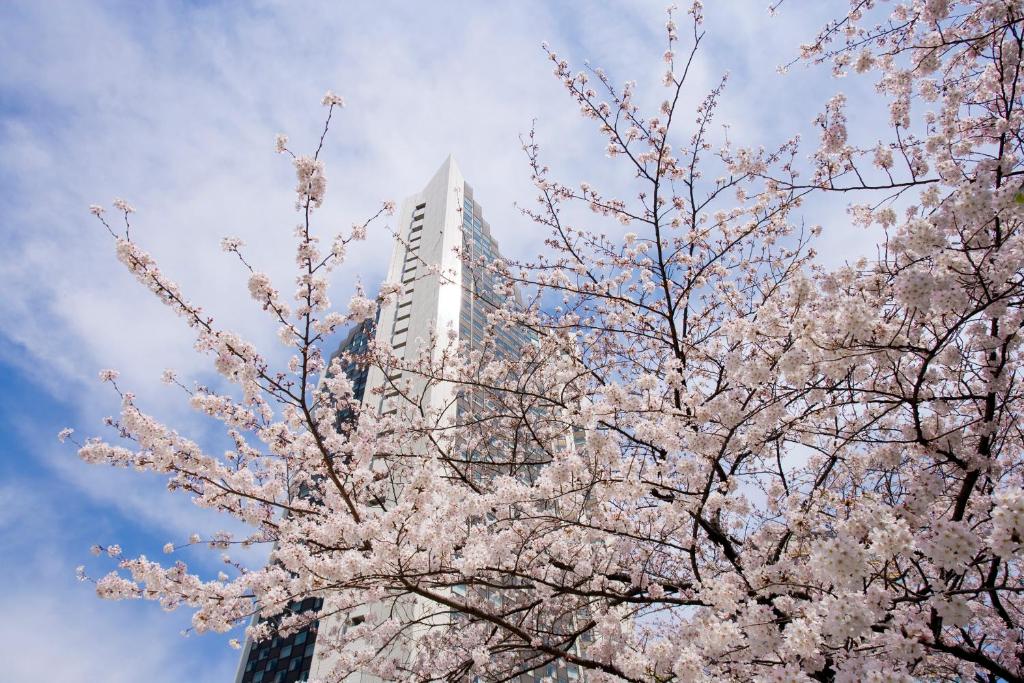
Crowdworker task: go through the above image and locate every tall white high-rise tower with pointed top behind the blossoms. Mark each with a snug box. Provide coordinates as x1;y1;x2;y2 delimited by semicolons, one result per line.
238;157;575;683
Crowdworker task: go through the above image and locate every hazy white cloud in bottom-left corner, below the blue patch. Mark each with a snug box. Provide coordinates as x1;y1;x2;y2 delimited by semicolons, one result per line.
0;478;237;683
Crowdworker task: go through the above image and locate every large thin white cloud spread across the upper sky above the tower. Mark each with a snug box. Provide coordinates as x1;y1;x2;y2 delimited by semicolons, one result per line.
0;3;880;403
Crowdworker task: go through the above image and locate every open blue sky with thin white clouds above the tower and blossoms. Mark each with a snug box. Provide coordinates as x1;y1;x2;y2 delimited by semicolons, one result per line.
0;0;884;683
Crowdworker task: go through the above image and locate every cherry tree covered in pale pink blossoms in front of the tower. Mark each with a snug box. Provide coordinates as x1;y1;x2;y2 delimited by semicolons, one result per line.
61;0;1024;681
